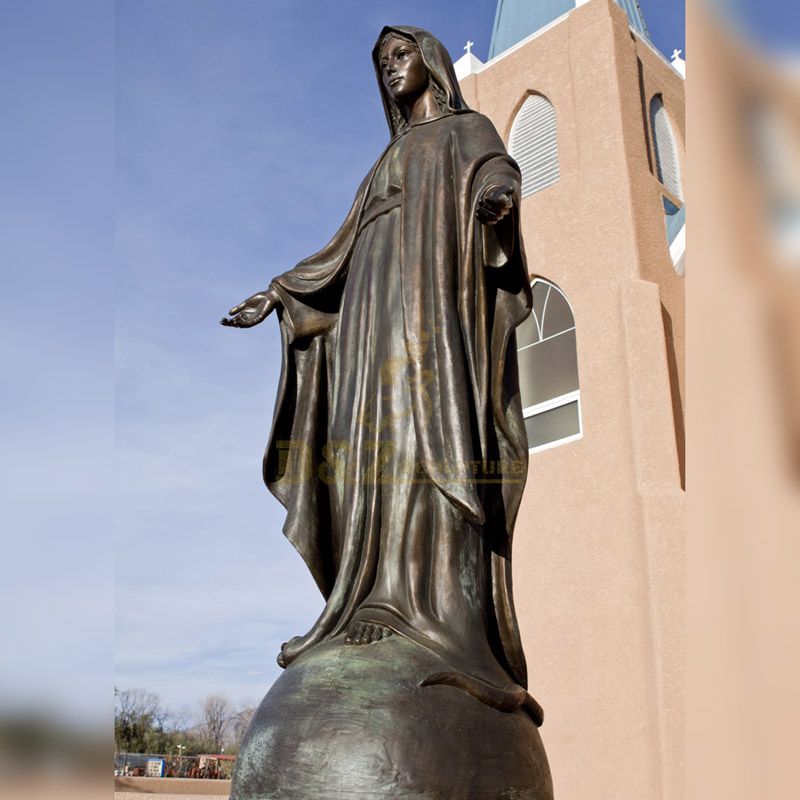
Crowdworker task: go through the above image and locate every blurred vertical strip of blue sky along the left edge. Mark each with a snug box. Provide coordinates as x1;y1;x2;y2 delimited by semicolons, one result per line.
0;0;114;718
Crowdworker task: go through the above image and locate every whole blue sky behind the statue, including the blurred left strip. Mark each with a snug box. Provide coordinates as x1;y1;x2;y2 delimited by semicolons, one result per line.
0;0;684;728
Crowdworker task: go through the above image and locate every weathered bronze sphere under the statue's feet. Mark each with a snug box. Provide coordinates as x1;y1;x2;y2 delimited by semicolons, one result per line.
230;635;553;800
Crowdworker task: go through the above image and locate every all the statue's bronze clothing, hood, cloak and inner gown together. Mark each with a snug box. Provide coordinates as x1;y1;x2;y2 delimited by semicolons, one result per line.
264;28;532;710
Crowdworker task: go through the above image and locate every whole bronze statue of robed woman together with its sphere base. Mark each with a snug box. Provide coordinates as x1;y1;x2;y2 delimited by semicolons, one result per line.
222;27;552;800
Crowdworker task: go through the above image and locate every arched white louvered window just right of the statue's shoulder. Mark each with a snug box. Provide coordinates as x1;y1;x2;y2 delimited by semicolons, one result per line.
508;94;561;197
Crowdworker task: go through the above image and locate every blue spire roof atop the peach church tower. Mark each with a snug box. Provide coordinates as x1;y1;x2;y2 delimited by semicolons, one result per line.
489;0;650;58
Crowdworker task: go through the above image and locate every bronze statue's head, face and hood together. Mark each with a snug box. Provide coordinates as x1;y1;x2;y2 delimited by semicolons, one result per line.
372;26;469;136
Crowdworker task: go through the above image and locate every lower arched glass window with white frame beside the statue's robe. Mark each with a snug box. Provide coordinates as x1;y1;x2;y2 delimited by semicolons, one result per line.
517;278;583;452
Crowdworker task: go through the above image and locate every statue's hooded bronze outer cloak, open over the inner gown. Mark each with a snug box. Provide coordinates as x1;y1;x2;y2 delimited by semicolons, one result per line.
264;28;531;720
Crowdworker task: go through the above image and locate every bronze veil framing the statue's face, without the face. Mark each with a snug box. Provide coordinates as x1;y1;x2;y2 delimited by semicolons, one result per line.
372;25;470;138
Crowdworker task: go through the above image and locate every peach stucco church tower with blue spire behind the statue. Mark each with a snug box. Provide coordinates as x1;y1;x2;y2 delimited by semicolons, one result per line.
456;0;685;800
